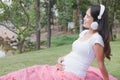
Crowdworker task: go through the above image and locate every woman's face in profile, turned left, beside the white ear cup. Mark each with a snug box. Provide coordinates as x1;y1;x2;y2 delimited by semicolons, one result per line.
83;8;93;28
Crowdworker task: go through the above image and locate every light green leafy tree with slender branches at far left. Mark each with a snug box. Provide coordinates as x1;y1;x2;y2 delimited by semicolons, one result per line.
0;0;34;53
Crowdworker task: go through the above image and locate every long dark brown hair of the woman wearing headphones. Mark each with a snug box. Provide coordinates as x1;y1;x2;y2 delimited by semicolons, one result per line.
90;5;111;60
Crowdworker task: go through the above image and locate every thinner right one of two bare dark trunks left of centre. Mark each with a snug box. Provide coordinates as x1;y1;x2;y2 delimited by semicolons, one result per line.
47;0;52;48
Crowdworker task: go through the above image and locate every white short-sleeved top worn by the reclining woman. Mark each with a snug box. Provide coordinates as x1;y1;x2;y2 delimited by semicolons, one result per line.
62;30;104;78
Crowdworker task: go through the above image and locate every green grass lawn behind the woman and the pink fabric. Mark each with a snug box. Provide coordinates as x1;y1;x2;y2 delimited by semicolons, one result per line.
0;41;120;80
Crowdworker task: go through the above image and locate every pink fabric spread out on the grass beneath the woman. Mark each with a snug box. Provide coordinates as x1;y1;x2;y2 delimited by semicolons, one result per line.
0;65;117;80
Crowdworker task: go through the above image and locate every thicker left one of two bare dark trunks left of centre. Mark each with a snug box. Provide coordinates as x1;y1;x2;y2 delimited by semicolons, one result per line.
35;0;41;50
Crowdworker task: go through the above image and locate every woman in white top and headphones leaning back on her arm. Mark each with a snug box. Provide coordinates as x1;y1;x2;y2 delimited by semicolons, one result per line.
58;4;116;80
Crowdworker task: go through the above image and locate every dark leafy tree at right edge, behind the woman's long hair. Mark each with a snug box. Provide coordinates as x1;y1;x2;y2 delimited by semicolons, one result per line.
101;0;120;40
